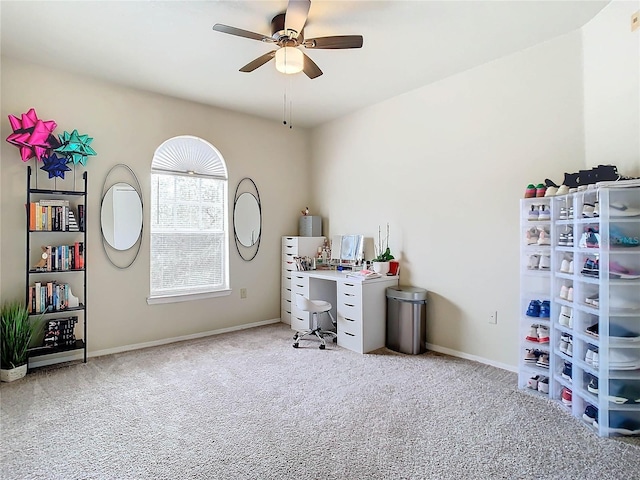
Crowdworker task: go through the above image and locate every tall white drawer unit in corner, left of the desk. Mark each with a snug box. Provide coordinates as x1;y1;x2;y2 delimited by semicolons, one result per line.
280;237;324;329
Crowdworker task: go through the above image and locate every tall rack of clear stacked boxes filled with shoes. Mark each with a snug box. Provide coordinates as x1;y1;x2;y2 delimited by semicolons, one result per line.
518;186;640;436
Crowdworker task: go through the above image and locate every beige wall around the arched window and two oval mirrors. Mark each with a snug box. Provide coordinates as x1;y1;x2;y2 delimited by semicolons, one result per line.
0;58;313;351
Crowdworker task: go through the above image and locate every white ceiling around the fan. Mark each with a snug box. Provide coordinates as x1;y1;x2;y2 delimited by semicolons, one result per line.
0;0;609;127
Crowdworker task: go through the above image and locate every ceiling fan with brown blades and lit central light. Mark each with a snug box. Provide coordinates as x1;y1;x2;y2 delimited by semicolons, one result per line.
213;0;362;79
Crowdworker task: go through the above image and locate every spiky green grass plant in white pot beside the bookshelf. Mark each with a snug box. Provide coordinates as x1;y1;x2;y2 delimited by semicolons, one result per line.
0;301;40;382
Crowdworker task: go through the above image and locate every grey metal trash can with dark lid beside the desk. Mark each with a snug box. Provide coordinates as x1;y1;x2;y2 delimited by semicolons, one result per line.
387;285;427;355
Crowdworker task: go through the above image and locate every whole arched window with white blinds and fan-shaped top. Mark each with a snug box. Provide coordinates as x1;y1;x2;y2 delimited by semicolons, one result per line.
147;135;230;303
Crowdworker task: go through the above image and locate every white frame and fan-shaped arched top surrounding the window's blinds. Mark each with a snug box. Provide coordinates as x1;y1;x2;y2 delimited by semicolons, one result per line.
147;135;231;305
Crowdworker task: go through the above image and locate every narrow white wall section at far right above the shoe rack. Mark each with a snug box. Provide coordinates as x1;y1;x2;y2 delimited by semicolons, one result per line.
582;0;640;176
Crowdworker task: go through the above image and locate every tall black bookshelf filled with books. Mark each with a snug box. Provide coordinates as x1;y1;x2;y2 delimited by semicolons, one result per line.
25;166;87;368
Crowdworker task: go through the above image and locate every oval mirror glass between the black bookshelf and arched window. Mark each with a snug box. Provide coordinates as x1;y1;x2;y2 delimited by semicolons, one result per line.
100;182;142;250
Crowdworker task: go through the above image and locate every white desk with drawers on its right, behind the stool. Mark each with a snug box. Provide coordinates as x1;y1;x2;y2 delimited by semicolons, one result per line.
291;270;399;353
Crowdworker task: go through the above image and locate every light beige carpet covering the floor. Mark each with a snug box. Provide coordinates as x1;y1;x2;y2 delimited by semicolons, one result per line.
0;324;640;480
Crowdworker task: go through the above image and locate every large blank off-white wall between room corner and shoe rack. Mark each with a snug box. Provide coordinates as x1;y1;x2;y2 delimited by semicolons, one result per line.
312;32;584;367
